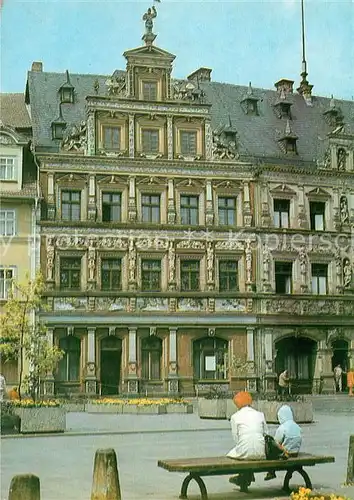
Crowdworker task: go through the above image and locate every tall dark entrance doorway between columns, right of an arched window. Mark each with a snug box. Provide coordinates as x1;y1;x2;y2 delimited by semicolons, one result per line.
100;336;122;395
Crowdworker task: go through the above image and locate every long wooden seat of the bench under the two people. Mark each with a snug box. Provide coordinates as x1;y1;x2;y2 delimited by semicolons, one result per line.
157;453;335;475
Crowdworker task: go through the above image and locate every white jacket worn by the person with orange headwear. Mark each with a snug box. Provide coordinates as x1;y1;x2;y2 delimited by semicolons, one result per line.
227;406;268;460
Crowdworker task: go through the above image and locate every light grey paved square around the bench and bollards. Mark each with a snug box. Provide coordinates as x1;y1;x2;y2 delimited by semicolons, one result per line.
1;413;354;500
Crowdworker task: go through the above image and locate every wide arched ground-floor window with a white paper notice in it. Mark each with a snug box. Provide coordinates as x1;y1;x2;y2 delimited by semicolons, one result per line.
193;337;228;380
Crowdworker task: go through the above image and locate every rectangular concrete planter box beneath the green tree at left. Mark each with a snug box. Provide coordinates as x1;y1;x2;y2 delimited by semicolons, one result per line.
13;406;66;434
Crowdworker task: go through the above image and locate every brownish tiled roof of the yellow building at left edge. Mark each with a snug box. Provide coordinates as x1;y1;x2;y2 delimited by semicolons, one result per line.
0;94;31;129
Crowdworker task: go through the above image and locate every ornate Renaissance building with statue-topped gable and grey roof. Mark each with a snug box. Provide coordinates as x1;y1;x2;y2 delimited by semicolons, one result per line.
26;11;354;394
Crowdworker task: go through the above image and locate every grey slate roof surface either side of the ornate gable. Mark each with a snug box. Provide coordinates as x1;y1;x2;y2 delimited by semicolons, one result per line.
28;71;354;163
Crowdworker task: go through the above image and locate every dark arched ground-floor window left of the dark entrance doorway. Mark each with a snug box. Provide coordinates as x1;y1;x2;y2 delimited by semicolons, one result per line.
58;335;81;382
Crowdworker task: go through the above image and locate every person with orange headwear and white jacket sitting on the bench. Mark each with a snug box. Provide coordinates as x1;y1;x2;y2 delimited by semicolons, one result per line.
227;391;268;486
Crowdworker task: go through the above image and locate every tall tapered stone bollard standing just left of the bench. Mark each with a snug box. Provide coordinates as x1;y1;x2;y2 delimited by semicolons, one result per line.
91;448;121;500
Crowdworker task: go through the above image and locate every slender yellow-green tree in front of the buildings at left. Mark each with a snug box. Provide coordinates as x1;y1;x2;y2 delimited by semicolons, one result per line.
0;274;64;400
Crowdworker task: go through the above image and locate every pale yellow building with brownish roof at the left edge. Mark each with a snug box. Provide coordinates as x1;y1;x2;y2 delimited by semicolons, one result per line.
0;94;39;386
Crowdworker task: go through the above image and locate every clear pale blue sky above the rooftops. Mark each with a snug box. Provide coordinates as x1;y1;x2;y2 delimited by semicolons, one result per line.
0;0;354;100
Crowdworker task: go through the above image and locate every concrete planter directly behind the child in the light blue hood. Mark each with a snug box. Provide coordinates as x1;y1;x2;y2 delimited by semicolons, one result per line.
252;400;313;424
